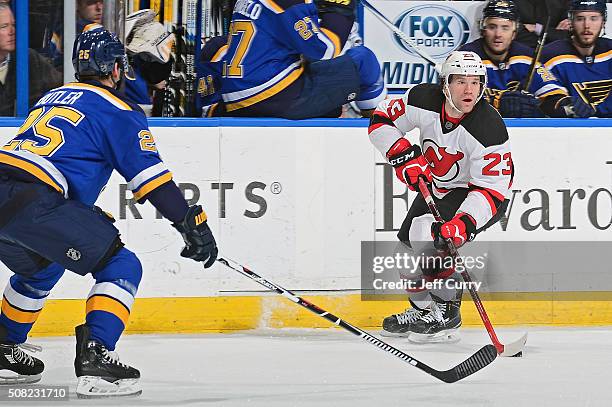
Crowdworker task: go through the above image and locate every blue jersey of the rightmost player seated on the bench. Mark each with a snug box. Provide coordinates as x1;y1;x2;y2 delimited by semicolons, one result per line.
542;37;612;117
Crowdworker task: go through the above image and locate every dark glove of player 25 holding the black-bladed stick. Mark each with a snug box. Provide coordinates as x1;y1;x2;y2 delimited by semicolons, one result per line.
172;205;219;268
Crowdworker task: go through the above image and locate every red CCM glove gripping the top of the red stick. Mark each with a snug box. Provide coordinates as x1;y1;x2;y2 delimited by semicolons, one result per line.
387;138;431;191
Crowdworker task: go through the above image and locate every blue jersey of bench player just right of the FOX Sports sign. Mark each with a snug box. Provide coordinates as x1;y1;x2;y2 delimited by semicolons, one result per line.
461;38;567;104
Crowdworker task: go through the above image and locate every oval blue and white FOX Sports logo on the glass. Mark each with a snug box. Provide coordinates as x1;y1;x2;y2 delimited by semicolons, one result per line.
392;4;470;59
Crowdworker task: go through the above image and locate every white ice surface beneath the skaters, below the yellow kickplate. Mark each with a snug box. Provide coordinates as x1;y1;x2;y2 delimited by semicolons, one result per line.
0;327;612;407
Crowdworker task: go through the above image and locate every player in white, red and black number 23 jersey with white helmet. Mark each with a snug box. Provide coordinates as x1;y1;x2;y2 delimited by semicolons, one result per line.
368;51;514;341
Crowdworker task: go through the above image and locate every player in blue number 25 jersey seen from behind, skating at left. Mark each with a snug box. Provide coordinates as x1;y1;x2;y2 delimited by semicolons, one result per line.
0;28;217;397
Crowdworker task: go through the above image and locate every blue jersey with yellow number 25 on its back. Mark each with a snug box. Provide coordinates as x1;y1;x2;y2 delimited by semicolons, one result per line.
0;82;172;205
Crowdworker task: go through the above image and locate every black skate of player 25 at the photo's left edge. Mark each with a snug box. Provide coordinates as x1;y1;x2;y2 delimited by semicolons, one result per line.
0;342;45;384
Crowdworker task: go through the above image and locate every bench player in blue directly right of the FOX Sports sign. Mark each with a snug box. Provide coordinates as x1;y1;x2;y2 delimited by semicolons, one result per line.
461;0;590;117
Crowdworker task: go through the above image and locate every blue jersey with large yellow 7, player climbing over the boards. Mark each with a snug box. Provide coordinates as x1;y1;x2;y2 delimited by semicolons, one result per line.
222;0;343;113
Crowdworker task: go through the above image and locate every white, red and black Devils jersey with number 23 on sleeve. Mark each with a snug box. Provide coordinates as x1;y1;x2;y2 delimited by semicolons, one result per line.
368;84;514;228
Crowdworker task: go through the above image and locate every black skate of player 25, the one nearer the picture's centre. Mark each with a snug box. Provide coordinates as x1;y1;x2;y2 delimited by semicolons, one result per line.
74;325;142;398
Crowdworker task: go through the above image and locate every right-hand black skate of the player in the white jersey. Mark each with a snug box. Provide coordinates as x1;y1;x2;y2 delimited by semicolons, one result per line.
409;295;461;343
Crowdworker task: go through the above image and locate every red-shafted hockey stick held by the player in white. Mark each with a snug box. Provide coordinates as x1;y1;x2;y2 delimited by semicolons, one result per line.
419;177;527;356
